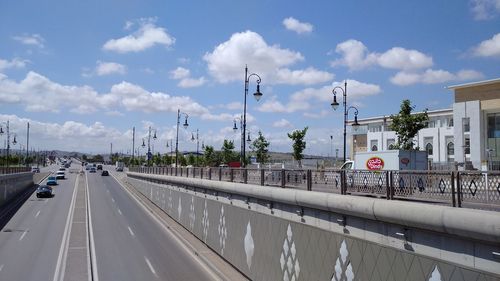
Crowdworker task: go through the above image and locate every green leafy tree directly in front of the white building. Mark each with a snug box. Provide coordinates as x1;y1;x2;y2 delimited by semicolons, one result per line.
389;100;429;150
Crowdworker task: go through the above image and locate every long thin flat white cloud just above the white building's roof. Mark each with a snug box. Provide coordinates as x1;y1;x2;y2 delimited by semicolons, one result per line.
390;69;483;86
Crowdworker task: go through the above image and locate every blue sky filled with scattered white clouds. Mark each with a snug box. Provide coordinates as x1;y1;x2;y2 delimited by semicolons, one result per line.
0;0;500;156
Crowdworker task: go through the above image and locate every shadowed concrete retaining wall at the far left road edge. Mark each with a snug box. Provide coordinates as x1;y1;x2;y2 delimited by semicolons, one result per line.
0;172;33;207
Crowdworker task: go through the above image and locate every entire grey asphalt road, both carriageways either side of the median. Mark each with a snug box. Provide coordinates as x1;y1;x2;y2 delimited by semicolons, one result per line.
0;166;219;281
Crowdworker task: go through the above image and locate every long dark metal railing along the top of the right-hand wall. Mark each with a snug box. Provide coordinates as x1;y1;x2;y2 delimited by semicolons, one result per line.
129;167;500;210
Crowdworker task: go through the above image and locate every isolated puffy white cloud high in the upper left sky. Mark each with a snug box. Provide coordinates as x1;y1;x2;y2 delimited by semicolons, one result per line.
103;19;175;53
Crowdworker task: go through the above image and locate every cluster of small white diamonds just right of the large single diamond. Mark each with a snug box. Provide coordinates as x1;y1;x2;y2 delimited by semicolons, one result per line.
280;224;300;281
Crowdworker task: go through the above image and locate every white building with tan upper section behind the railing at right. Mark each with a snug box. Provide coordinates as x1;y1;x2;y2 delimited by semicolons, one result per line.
348;75;500;170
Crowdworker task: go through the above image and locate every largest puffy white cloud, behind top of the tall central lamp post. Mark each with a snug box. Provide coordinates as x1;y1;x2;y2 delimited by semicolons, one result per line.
203;31;333;85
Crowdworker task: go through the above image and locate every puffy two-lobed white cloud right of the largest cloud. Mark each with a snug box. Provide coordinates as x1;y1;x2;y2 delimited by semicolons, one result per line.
331;39;433;70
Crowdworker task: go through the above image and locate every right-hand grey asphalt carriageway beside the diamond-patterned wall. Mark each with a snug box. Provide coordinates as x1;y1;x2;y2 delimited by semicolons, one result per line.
87;168;213;281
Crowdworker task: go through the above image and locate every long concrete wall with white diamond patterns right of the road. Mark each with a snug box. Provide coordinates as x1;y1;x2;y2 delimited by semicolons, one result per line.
126;173;500;280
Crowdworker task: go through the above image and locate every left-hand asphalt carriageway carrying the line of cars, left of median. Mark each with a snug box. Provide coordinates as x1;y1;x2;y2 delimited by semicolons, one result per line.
0;166;76;280
